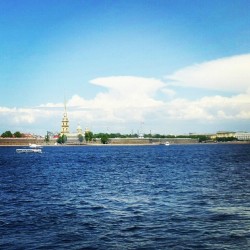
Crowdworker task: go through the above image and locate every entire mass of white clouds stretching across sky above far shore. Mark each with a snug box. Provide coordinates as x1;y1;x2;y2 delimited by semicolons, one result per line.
0;54;250;133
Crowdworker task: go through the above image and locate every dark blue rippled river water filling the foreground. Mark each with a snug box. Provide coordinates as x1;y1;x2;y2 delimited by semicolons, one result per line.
0;144;250;250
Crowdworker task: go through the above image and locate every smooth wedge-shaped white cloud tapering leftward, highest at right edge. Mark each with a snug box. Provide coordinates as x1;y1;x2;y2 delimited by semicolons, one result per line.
166;54;250;93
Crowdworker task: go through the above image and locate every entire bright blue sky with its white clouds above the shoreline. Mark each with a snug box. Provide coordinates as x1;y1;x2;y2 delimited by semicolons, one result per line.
0;0;250;135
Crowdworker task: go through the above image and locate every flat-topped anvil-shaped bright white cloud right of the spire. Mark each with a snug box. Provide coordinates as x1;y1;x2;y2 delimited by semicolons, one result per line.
68;76;166;123
